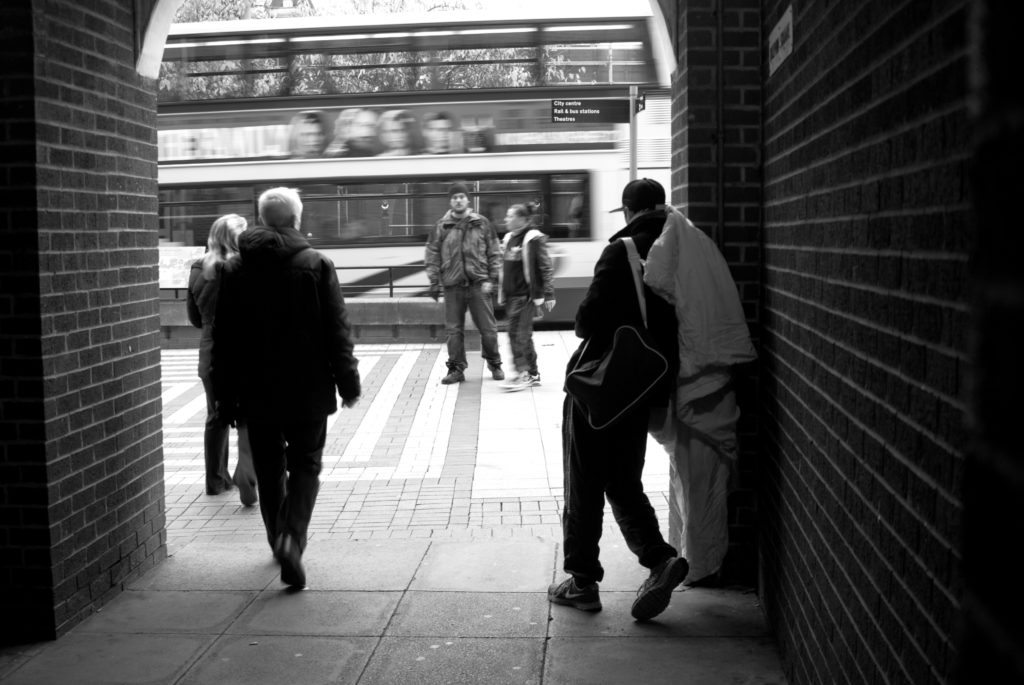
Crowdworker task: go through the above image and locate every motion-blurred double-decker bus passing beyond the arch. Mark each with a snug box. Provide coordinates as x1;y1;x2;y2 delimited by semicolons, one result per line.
158;5;670;323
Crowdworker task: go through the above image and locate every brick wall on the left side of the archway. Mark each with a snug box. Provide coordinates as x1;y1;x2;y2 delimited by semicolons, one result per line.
0;0;165;639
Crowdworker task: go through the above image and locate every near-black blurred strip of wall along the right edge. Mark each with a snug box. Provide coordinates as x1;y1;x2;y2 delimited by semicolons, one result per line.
956;0;1024;685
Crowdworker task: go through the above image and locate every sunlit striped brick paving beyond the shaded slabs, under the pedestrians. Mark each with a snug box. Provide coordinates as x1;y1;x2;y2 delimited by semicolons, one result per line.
163;331;668;548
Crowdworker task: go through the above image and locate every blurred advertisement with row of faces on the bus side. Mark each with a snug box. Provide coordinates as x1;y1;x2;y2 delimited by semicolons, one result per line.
158;100;629;163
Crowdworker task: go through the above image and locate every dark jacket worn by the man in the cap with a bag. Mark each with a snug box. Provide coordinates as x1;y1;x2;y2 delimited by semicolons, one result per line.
568;210;679;404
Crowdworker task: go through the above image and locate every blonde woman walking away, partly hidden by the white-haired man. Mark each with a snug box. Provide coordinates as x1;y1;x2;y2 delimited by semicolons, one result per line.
185;214;256;507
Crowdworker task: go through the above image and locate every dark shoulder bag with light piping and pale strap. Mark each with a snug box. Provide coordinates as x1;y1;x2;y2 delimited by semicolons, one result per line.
565;238;669;430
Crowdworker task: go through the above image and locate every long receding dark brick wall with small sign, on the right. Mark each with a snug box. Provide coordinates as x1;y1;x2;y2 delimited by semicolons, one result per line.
759;0;970;685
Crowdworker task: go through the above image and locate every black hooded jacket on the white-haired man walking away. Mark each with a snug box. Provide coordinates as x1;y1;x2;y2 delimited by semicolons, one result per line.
211;226;361;422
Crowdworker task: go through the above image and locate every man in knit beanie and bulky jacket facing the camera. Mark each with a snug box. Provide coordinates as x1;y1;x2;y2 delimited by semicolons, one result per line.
424;183;505;385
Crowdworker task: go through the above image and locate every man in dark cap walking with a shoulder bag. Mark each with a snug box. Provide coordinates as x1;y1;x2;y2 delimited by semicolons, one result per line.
548;178;688;620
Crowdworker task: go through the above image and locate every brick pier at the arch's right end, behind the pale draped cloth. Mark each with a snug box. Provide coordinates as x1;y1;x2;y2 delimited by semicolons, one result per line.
659;0;761;583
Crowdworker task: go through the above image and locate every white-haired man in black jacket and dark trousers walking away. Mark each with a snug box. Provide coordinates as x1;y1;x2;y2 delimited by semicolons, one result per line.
212;187;361;587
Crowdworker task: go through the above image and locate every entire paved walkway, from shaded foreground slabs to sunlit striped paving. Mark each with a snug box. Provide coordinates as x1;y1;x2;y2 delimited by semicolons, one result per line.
0;331;784;685
